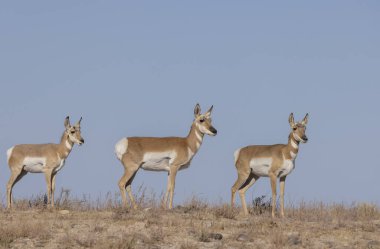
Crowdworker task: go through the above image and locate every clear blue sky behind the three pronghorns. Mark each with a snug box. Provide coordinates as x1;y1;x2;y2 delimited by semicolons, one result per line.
0;1;380;204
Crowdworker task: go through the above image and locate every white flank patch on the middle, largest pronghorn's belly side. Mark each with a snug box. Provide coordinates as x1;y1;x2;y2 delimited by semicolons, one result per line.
141;151;177;171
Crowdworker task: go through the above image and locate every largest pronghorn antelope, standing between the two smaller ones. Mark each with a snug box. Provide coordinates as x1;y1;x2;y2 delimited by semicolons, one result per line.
115;104;217;209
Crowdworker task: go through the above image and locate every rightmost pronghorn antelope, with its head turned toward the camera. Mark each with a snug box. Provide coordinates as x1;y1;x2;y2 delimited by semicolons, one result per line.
231;113;308;217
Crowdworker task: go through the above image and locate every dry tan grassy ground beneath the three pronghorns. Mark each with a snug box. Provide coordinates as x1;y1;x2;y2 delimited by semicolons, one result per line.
0;188;380;249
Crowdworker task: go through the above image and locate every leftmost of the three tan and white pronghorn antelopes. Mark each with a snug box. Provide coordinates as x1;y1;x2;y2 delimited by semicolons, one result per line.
7;117;84;208
